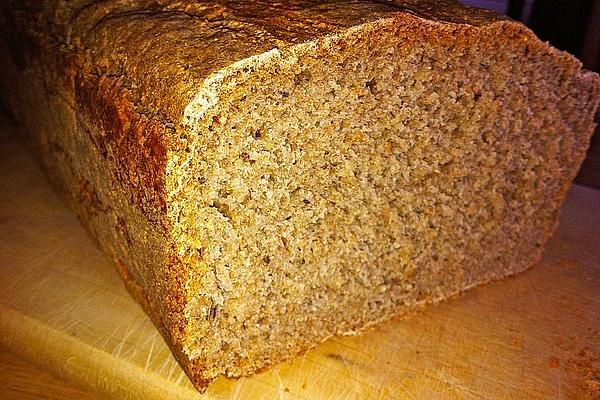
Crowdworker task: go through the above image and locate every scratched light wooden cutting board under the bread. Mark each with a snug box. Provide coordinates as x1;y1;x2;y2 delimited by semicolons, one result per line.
0;122;600;399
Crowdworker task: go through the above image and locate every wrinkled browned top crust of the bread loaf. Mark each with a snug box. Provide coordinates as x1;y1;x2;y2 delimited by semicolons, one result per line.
9;0;503;122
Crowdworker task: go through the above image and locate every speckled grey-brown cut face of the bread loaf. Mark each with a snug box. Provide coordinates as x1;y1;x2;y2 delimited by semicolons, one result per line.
169;16;594;382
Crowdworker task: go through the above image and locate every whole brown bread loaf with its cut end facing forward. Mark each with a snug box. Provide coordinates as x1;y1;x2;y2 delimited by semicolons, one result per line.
0;0;600;391
